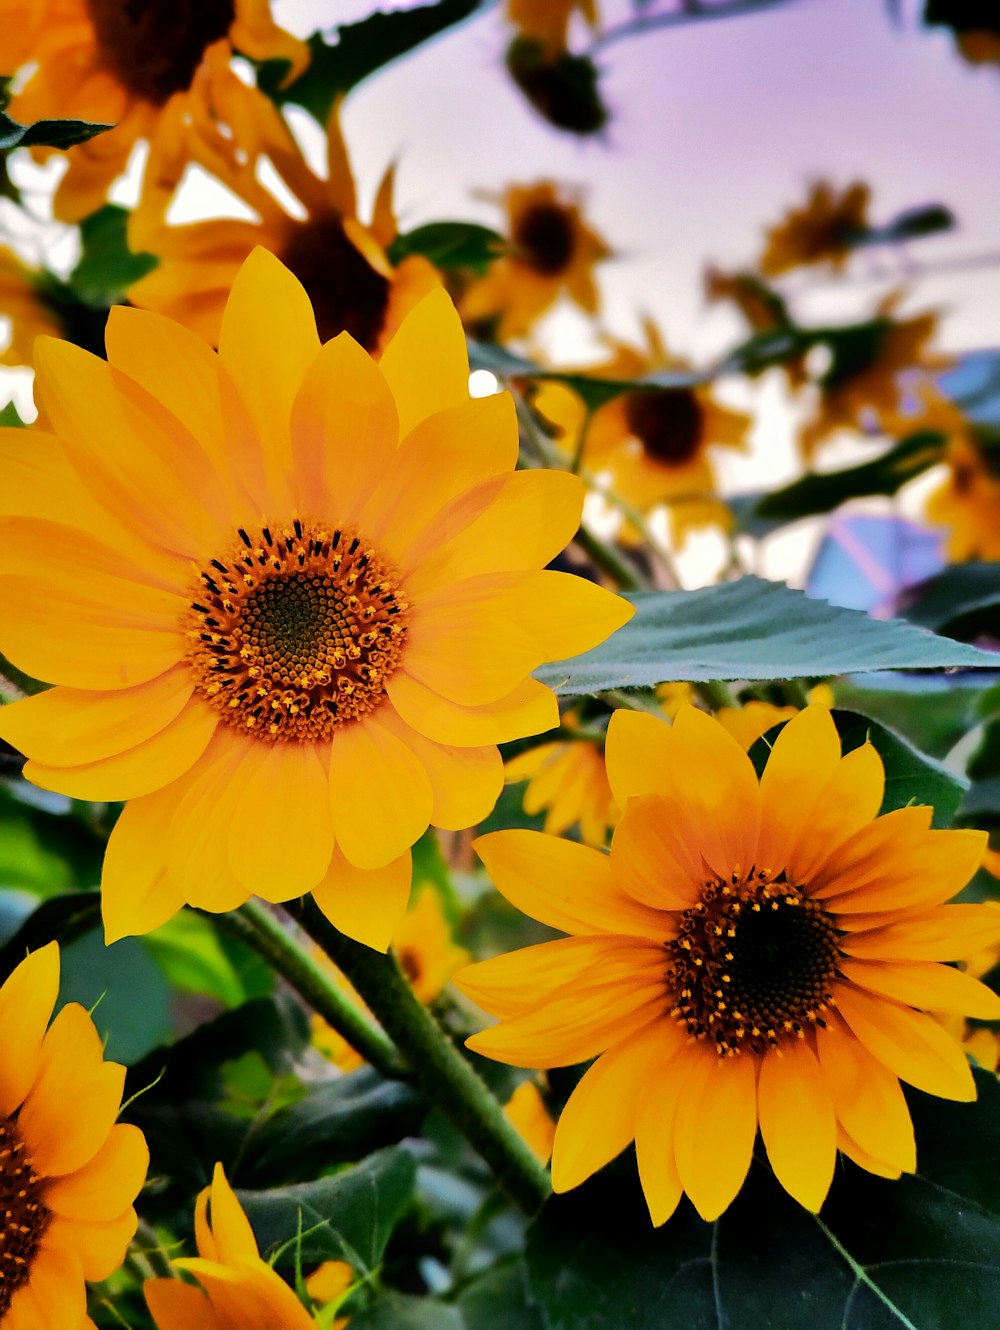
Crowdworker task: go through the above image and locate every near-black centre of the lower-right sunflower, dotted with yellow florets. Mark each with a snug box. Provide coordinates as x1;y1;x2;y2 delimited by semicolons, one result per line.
666;872;840;1057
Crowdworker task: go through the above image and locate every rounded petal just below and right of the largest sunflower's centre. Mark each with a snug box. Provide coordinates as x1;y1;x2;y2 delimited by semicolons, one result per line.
330;714;434;868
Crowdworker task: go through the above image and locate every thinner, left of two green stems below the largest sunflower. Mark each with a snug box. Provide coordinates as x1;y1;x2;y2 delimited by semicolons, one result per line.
222;900;403;1080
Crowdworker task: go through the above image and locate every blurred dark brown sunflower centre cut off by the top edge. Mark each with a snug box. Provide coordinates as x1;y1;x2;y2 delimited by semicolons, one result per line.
85;0;235;106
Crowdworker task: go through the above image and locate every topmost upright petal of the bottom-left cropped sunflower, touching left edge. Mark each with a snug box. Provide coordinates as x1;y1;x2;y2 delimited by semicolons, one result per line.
0;942;59;1117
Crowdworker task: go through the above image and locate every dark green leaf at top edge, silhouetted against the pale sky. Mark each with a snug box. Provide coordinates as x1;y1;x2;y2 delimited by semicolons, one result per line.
257;0;483;124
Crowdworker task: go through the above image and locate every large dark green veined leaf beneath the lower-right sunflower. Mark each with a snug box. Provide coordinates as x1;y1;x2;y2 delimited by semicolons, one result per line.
528;1072;1000;1330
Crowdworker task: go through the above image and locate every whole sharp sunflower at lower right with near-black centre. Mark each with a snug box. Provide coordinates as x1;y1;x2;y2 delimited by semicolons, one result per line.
456;706;1000;1224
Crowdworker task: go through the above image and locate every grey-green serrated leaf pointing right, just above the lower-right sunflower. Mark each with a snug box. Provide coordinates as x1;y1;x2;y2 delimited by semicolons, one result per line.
535;577;1000;694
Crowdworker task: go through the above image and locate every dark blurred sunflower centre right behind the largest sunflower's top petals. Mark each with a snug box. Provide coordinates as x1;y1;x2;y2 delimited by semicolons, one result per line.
281;214;390;351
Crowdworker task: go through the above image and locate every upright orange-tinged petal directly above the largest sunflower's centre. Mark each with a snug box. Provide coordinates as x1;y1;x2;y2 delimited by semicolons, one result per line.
291;324;399;525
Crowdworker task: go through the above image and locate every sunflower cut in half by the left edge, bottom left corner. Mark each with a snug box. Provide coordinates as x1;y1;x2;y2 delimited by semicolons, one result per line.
0;943;149;1330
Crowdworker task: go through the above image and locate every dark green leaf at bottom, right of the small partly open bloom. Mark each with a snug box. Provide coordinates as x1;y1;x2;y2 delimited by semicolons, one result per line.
238;1145;416;1274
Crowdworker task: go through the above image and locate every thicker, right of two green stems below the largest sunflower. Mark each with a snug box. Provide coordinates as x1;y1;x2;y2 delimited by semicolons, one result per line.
285;896;551;1214
